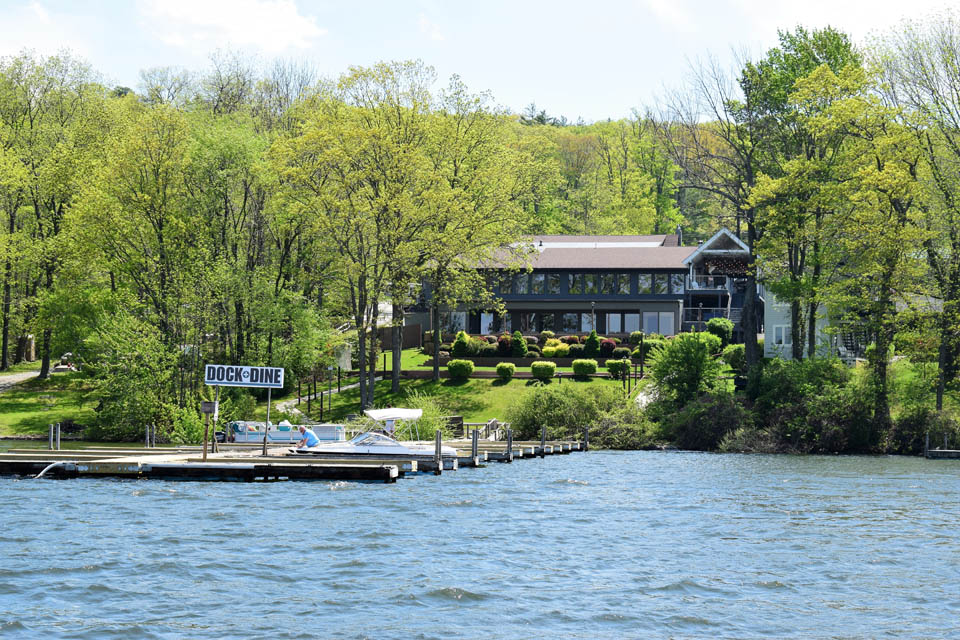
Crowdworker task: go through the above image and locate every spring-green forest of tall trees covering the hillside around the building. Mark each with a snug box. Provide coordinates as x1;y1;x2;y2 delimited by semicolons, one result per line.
0;15;960;433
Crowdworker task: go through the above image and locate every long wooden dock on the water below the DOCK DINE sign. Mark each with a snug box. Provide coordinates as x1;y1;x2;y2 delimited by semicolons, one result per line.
0;438;584;483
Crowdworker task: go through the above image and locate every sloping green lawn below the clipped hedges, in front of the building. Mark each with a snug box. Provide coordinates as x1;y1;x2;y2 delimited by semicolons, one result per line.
288;378;621;422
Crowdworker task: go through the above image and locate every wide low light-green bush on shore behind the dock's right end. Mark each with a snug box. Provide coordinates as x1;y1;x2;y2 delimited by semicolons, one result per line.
507;380;624;440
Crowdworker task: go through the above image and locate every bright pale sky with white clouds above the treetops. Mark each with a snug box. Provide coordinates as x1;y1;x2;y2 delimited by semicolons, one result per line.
0;0;952;122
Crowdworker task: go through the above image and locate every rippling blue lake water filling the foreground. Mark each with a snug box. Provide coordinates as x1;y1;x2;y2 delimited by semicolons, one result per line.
0;451;960;639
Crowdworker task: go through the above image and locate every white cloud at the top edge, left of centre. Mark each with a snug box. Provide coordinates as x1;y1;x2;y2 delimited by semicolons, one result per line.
138;0;327;54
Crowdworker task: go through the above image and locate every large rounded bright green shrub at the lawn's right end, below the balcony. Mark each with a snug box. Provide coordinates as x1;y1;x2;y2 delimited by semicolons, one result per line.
649;333;722;406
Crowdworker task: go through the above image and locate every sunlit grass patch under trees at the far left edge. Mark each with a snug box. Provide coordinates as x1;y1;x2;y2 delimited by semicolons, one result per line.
0;366;94;435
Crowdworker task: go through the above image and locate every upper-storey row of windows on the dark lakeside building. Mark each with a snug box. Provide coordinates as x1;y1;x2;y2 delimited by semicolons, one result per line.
497;273;684;296
